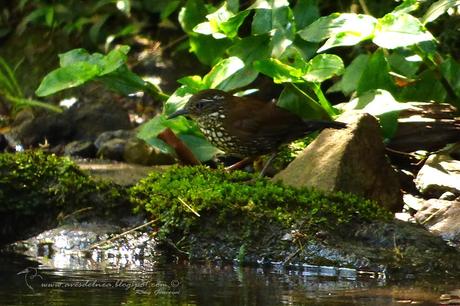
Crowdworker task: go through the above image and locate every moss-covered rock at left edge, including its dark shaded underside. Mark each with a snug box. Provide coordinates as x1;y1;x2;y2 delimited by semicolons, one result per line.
0;151;129;244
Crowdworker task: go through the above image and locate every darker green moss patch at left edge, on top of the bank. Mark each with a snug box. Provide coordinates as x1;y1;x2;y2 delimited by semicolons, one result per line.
0;151;122;215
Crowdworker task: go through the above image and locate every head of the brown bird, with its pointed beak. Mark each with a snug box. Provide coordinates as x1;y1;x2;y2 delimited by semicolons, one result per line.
168;89;233;119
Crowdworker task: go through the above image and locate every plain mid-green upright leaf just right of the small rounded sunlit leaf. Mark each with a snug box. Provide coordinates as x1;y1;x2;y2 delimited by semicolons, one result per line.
328;54;369;96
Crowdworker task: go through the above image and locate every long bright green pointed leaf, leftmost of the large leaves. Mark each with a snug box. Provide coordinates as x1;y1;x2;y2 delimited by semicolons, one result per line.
35;62;99;97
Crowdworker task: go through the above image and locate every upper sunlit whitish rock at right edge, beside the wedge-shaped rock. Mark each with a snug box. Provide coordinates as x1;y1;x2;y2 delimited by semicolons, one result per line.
415;154;460;198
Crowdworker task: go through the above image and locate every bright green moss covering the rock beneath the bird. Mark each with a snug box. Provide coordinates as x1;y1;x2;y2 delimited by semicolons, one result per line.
130;166;391;255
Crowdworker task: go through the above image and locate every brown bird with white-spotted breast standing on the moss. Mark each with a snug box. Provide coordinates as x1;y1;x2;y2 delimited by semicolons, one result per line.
168;89;346;175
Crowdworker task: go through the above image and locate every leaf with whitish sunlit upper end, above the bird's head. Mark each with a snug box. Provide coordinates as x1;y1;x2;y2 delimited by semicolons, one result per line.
203;56;244;88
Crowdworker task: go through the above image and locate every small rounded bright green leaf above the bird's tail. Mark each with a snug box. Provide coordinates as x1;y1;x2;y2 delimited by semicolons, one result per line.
303;54;344;83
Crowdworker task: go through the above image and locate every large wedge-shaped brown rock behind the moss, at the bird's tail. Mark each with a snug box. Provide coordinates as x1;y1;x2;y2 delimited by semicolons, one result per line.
274;113;402;211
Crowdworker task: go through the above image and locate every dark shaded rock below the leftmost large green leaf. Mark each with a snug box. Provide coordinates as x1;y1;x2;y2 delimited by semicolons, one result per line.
68;102;132;140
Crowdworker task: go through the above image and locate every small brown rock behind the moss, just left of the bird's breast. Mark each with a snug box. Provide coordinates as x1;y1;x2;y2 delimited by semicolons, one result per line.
123;138;175;166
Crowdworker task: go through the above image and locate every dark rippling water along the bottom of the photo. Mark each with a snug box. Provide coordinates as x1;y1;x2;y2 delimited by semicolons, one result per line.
0;254;460;306
